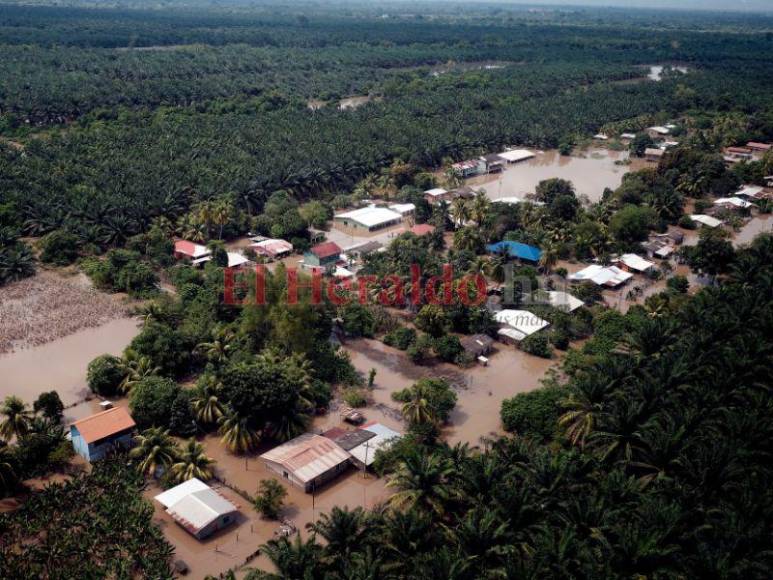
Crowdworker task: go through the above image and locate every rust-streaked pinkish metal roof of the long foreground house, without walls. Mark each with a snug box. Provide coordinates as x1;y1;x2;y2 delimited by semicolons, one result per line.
260;433;350;483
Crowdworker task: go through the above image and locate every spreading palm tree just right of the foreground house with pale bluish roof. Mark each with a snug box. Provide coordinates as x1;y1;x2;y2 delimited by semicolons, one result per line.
387;451;454;516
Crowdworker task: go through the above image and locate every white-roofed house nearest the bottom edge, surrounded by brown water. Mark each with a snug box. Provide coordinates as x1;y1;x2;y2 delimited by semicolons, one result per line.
155;477;239;540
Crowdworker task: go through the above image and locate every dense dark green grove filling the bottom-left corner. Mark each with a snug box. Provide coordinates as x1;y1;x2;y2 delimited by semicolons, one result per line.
0;458;173;578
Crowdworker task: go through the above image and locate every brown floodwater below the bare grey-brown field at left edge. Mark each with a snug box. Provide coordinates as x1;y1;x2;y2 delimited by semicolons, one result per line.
0;318;140;406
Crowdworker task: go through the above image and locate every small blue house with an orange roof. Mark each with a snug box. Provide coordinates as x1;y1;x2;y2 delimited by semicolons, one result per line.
70;407;137;461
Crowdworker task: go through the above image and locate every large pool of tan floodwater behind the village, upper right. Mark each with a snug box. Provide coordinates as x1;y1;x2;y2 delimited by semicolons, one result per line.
467;149;650;202
